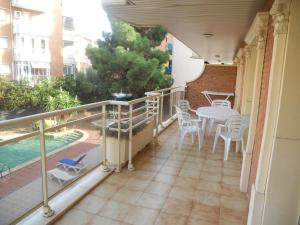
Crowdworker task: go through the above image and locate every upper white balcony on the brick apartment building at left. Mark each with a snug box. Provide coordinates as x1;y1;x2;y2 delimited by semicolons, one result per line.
13;19;50;37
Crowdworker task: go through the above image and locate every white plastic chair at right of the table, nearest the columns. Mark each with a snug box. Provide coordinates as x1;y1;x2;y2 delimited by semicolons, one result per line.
212;115;247;160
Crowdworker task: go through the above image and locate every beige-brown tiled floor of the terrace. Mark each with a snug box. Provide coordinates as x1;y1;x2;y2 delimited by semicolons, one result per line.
56;123;248;225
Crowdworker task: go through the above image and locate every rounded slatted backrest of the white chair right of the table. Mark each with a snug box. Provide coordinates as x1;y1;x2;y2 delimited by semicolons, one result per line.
225;115;246;140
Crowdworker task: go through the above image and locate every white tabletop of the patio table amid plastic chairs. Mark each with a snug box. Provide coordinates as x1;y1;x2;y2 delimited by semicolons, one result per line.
196;106;239;121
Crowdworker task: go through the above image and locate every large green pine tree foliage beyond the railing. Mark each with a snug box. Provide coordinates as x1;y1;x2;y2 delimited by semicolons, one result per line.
87;19;173;100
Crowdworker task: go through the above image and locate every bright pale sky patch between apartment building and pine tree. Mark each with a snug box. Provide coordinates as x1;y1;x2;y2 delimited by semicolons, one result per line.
65;0;111;40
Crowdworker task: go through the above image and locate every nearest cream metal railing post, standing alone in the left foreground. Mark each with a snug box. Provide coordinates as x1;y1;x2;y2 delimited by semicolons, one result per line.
40;119;54;217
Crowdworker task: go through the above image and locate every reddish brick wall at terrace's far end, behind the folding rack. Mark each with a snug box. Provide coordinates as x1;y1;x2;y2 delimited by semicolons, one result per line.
186;65;237;108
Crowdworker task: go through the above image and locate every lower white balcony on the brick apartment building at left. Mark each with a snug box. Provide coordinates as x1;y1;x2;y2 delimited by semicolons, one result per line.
14;48;51;63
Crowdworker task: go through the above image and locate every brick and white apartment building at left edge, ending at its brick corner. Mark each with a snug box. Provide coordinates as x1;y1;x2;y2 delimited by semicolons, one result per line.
0;0;63;82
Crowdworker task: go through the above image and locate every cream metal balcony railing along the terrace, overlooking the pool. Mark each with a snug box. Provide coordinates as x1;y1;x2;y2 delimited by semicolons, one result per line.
0;87;185;224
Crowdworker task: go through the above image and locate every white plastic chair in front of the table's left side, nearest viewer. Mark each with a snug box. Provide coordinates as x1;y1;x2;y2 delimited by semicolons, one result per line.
176;107;206;151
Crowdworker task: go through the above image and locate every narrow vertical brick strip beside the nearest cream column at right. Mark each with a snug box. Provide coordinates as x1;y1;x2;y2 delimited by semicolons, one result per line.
248;0;274;194
